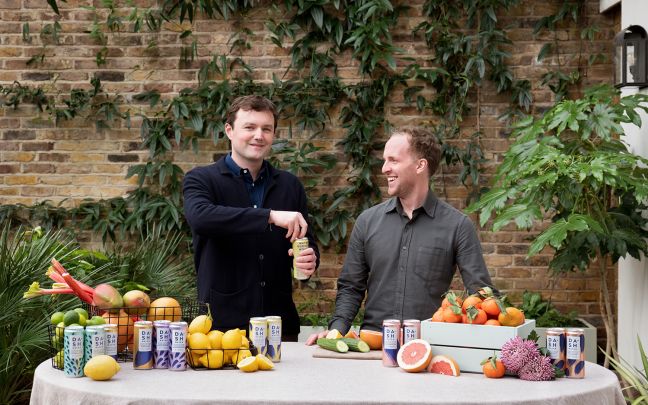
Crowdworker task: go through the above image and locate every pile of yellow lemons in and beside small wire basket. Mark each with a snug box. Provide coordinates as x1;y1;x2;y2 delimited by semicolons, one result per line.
187;315;274;372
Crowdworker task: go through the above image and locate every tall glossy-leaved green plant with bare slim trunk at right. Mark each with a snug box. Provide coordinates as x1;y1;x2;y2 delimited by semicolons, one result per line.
468;85;648;366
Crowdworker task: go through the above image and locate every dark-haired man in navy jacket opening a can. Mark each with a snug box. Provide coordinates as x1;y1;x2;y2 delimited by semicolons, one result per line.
183;96;319;340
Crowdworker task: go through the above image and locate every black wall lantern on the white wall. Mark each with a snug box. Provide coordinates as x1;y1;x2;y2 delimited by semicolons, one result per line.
614;25;648;87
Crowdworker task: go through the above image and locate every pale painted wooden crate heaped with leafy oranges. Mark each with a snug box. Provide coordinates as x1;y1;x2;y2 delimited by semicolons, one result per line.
421;319;535;373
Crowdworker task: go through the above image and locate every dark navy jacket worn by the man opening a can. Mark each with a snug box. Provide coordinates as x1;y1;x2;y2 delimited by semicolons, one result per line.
183;158;319;335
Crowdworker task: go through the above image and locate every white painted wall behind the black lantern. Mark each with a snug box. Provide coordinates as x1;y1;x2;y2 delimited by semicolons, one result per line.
616;0;648;370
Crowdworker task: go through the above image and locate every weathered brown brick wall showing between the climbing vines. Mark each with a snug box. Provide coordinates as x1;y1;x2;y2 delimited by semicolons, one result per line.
0;0;618;348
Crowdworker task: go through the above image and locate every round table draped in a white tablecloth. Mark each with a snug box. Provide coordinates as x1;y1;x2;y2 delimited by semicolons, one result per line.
31;342;625;405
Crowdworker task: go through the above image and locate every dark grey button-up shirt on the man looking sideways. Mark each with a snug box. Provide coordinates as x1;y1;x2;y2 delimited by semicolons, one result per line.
329;191;492;333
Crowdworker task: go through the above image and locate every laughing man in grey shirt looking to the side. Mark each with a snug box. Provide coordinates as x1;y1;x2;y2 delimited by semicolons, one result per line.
307;127;492;344
